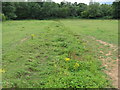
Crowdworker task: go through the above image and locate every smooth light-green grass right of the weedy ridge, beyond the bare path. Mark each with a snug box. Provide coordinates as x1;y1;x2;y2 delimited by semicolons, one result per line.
60;19;118;45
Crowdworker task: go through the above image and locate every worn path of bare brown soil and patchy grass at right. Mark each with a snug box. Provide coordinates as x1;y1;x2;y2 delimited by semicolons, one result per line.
80;37;118;88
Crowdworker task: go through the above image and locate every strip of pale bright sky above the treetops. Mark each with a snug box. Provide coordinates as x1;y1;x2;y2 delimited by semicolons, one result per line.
52;0;115;4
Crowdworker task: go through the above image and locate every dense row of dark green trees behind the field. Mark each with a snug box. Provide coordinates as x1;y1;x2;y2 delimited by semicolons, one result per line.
1;1;120;20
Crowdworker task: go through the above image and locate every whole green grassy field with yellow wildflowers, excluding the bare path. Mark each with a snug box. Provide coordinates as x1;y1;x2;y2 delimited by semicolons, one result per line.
2;19;118;88
